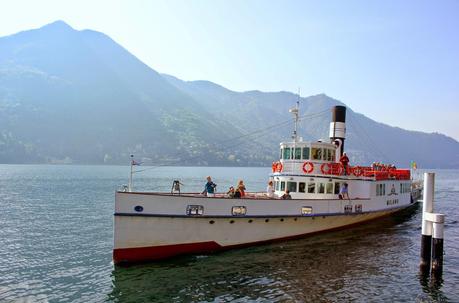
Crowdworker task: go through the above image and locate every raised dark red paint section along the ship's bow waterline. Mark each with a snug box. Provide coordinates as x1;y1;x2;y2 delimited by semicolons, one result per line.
113;241;222;264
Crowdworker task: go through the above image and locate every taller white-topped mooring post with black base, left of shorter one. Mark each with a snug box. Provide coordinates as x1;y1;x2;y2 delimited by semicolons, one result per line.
419;173;435;273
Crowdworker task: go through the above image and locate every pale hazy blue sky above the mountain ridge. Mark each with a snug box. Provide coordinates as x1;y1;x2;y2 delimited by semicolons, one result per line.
0;0;459;139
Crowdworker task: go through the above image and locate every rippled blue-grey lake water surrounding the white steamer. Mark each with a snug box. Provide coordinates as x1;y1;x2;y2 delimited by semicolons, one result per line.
0;165;459;302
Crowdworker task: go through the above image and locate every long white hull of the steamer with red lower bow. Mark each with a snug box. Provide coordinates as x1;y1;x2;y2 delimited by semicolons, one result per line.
113;192;412;263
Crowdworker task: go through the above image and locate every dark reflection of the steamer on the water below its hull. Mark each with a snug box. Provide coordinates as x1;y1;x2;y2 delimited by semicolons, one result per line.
108;211;452;302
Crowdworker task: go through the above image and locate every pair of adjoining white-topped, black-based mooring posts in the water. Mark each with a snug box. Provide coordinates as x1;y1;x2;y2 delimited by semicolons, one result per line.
419;173;445;276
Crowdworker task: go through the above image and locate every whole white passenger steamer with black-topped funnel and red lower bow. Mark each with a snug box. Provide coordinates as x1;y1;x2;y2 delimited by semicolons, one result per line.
113;104;421;264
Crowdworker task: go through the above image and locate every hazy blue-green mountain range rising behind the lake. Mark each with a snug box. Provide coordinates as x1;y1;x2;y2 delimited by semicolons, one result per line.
0;21;459;167
